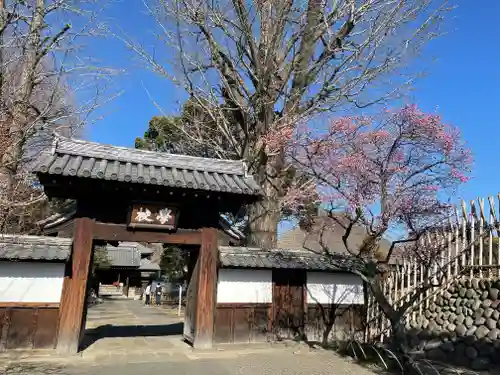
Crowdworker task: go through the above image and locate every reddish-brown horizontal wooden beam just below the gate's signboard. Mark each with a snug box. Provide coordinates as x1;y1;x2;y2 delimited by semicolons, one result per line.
94;223;201;245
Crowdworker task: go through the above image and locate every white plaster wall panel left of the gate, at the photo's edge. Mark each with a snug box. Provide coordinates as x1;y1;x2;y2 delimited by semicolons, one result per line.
0;262;64;303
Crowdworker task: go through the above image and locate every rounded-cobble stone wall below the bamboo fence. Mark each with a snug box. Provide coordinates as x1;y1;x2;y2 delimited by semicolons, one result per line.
408;278;500;370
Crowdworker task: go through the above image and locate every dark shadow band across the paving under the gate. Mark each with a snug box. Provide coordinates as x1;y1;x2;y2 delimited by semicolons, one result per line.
80;322;184;351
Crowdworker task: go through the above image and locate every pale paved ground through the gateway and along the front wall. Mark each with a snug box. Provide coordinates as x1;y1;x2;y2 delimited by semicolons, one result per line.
0;297;373;375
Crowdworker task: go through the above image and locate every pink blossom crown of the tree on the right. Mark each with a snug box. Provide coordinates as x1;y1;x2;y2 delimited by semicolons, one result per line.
282;105;472;248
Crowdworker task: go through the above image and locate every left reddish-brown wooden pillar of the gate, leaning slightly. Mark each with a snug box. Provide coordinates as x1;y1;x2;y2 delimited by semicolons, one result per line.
57;218;94;354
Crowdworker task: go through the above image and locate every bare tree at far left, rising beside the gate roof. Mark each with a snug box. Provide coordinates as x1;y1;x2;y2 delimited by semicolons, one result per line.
0;0;120;234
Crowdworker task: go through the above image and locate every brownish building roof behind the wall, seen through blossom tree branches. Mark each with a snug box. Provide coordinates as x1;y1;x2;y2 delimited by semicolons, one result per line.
278;216;390;264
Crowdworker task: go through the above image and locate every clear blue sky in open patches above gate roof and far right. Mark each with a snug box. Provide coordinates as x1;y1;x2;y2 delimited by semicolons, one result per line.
86;0;500;223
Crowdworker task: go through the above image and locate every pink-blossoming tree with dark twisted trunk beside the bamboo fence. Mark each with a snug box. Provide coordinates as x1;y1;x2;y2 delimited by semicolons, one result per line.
274;105;471;356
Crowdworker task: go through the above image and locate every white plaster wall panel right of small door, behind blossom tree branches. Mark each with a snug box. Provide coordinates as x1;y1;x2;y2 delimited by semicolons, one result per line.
307;272;364;305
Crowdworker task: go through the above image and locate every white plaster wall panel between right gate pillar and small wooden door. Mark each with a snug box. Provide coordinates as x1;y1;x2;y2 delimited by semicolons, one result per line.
217;269;273;303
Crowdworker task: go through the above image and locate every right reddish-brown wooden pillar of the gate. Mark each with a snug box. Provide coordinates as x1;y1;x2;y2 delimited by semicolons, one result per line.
193;228;219;349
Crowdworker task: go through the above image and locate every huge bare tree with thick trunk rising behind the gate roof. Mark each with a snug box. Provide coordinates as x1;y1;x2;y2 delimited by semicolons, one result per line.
121;0;449;248
